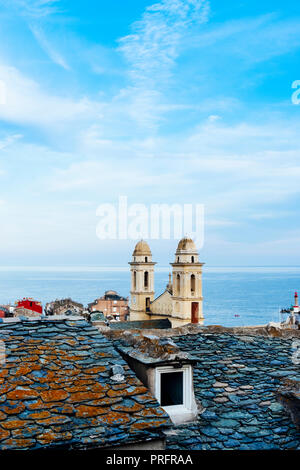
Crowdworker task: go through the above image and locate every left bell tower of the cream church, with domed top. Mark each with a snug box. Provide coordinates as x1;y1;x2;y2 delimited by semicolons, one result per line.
129;240;156;321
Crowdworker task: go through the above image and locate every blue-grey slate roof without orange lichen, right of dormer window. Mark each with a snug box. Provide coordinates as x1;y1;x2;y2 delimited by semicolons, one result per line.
167;333;300;450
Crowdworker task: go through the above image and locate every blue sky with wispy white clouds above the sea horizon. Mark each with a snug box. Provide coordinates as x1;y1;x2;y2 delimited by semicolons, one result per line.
0;0;300;266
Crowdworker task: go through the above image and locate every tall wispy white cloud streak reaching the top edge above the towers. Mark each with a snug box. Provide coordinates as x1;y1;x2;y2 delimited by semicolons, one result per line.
119;0;209;127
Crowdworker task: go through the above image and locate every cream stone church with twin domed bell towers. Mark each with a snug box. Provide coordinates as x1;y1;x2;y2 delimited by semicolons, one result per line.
129;237;204;328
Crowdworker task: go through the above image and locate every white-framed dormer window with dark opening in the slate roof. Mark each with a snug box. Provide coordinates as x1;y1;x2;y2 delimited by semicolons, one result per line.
155;364;192;416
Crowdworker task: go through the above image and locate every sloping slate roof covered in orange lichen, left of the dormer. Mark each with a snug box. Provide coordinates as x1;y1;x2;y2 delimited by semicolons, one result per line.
0;317;170;450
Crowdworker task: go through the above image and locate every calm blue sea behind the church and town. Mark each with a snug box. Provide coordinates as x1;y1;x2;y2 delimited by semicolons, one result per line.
0;267;300;326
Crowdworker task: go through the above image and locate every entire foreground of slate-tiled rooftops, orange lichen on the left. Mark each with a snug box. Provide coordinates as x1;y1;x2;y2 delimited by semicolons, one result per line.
0;317;300;450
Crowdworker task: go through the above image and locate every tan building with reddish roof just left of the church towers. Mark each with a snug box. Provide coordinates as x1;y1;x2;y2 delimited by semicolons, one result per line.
88;290;129;321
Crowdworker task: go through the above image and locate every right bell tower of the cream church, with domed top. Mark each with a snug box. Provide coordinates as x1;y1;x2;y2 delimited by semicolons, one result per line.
171;237;204;323
